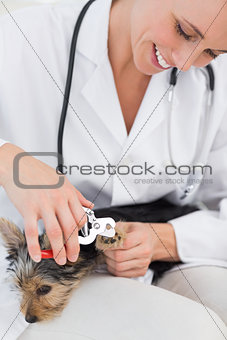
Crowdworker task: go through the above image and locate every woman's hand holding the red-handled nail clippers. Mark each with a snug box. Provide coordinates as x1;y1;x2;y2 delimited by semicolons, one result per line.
0;143;93;265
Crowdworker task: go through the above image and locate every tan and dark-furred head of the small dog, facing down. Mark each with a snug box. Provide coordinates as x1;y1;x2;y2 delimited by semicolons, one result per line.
0;219;93;323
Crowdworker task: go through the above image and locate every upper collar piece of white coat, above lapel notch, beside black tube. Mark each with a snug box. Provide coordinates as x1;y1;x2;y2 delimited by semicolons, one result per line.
77;0;112;65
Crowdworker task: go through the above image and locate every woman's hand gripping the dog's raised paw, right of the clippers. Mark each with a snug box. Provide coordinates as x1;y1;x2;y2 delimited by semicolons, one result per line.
104;222;179;277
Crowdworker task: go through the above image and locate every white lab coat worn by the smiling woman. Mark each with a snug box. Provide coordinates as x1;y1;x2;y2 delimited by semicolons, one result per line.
0;0;227;338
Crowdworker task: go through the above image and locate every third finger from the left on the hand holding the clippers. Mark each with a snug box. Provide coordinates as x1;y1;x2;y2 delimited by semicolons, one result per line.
57;206;80;262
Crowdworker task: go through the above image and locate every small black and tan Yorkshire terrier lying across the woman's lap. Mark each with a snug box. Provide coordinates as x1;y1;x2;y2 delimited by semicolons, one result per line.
0;199;198;323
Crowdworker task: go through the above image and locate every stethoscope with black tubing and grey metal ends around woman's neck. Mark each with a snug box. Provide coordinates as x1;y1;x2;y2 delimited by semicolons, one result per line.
58;0;215;199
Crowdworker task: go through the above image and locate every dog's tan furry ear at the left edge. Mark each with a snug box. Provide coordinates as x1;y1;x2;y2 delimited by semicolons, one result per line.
0;218;26;254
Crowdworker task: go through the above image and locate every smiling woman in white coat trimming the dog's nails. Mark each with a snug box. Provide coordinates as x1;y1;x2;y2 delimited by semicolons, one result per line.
0;0;227;340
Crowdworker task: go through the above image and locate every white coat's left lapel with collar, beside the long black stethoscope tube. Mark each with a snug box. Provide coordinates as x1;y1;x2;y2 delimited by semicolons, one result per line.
77;0;127;145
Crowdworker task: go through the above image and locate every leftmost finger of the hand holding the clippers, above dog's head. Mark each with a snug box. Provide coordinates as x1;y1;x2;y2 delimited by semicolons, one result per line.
24;214;41;262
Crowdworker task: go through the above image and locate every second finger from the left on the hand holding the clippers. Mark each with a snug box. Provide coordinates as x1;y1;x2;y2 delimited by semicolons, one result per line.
42;211;66;265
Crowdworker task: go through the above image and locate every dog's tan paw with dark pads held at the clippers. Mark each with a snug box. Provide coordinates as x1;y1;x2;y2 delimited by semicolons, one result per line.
95;228;126;250
